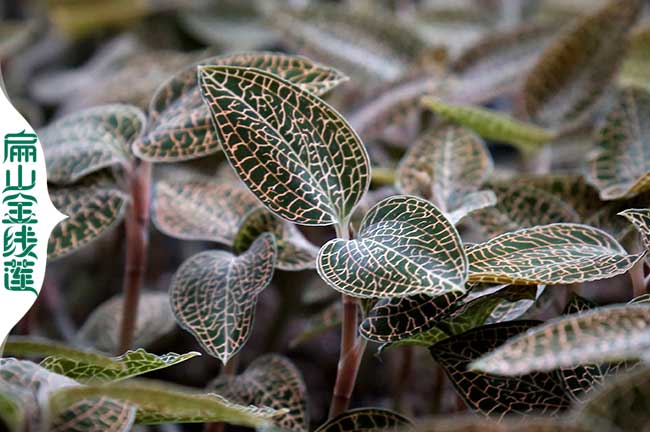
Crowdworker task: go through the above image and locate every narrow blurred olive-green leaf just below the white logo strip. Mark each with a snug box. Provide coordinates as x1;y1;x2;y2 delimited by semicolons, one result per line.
4;336;124;373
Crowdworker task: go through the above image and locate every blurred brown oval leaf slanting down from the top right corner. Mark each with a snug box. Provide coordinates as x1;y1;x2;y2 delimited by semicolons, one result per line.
523;0;642;129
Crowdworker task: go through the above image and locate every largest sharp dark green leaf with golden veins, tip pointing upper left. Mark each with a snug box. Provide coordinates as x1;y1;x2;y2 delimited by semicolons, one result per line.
199;66;370;225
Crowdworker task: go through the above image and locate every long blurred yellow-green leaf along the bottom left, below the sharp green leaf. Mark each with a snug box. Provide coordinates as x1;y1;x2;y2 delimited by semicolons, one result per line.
50;380;276;427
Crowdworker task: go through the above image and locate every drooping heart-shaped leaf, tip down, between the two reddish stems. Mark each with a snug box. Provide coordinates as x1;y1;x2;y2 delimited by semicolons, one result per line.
169;233;277;364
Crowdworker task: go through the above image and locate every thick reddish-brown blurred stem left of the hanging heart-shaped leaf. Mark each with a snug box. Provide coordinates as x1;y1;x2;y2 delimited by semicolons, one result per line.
118;162;151;354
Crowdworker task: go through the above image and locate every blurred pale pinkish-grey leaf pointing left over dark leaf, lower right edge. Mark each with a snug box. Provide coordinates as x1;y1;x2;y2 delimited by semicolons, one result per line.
471;304;650;376
